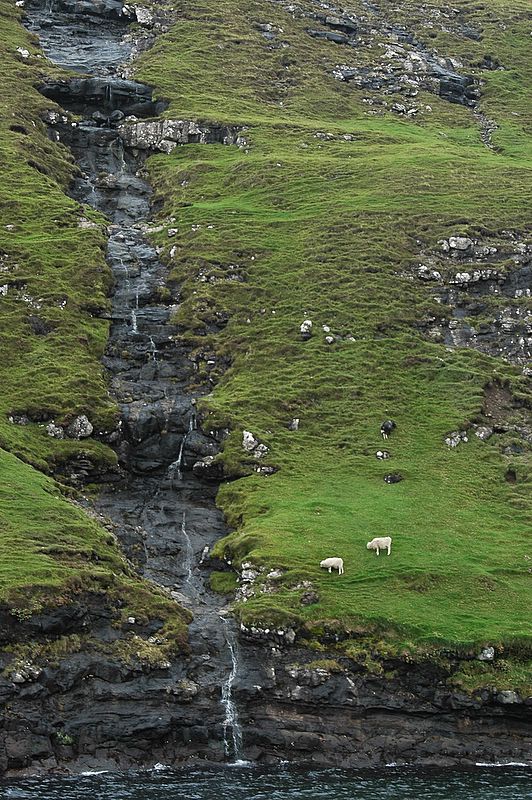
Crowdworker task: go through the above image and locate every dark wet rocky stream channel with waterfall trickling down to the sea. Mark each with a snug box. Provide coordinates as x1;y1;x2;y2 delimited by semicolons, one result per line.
26;0;242;762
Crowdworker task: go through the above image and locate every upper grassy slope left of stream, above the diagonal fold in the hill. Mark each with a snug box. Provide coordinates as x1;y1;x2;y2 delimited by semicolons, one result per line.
0;0;117;471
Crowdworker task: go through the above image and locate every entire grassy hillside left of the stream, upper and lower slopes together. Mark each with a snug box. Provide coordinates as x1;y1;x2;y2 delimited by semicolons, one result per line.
0;2;188;657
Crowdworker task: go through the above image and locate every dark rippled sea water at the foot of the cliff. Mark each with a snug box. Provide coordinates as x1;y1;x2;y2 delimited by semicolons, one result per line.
0;766;532;800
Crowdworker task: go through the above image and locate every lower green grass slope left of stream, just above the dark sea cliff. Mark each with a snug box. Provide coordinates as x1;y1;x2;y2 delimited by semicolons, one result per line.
0;450;190;658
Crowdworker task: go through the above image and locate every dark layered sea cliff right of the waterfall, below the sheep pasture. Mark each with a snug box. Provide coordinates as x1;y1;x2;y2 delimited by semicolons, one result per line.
222;631;532;767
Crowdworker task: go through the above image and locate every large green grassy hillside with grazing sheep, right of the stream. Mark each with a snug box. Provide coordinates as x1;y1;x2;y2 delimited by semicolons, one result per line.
134;0;532;668
